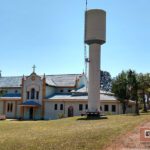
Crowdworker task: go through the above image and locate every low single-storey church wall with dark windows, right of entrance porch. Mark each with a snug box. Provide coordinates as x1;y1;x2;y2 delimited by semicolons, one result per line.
45;100;126;119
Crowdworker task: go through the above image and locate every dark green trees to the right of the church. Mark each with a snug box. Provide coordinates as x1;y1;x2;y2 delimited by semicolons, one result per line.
112;69;150;114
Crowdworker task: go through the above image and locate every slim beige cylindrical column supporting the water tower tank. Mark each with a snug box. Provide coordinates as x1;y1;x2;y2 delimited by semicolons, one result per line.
88;44;101;112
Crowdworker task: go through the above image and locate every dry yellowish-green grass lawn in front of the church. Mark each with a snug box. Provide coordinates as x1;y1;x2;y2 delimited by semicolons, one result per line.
0;115;150;150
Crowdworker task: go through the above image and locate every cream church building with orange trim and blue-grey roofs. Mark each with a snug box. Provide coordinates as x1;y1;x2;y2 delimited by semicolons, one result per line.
0;71;135;120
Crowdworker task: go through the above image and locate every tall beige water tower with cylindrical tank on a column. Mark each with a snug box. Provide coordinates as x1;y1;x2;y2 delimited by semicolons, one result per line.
85;9;106;116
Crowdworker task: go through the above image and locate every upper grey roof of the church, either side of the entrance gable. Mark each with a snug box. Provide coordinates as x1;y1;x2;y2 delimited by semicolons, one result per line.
0;74;81;88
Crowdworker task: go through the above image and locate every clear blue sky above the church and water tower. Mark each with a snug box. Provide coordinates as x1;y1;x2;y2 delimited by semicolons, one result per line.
0;0;150;76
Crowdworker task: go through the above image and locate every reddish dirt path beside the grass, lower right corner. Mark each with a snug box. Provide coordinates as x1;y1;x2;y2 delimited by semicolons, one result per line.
105;122;150;150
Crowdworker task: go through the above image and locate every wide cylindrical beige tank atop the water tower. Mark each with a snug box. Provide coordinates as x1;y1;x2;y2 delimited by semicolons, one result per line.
85;9;106;45
